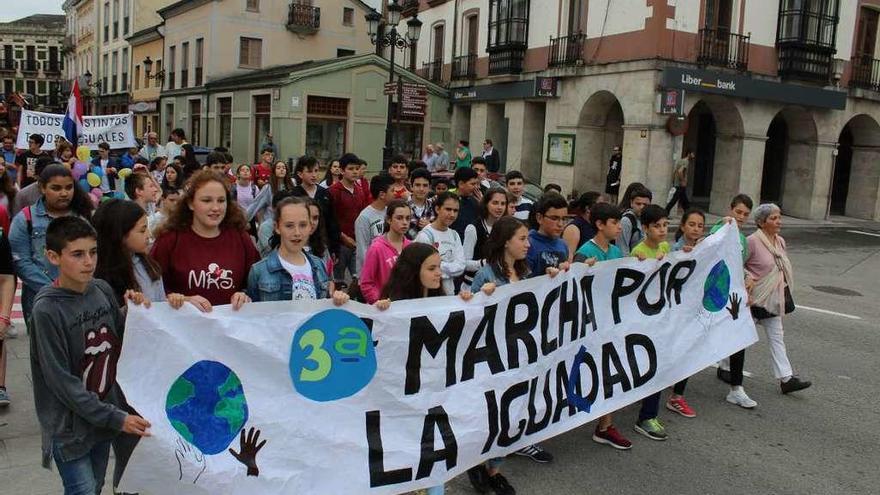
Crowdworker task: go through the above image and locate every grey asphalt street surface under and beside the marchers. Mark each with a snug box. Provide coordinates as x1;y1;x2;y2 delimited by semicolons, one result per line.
0;224;880;495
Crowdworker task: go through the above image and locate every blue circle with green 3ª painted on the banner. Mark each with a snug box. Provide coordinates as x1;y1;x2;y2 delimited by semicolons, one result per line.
290;309;376;402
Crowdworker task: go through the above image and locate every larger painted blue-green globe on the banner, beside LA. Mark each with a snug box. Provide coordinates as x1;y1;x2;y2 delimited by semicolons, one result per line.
165;361;248;455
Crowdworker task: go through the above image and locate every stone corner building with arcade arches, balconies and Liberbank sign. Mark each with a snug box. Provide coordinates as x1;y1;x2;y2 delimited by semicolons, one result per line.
412;0;880;220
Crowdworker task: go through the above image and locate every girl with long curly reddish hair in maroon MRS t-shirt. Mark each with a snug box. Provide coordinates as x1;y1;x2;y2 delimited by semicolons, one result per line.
151;170;260;311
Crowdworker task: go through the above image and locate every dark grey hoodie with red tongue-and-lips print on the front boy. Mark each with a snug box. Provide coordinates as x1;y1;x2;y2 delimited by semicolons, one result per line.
30;279;126;467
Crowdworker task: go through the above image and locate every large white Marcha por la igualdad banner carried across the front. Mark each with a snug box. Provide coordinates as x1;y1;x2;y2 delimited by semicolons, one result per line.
118;226;757;495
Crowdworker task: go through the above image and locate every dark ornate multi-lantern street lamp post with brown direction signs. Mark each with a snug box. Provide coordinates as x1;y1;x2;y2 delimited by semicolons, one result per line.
366;0;422;168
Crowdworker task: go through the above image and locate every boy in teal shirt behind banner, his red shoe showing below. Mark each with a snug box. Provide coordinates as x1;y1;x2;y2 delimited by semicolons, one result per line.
574;203;632;450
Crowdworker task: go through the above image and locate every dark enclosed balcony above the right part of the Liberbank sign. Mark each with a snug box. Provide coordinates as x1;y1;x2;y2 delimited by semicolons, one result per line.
776;9;839;83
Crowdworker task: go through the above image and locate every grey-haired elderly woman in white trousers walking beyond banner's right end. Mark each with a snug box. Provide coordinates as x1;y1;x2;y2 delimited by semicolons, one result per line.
745;203;812;394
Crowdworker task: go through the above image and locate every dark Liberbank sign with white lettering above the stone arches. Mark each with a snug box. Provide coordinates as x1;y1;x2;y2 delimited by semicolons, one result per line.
660;67;846;110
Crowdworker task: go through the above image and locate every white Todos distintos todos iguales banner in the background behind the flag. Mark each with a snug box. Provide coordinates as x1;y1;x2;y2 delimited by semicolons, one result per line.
15;110;137;151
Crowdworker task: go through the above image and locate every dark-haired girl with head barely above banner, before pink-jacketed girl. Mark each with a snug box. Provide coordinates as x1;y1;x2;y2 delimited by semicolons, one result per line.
376;242;478;495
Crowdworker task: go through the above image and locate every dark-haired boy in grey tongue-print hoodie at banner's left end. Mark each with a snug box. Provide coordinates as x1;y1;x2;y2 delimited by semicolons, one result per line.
30;216;150;495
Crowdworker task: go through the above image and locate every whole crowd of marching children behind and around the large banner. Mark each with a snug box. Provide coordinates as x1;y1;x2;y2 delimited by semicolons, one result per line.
0;137;809;494
